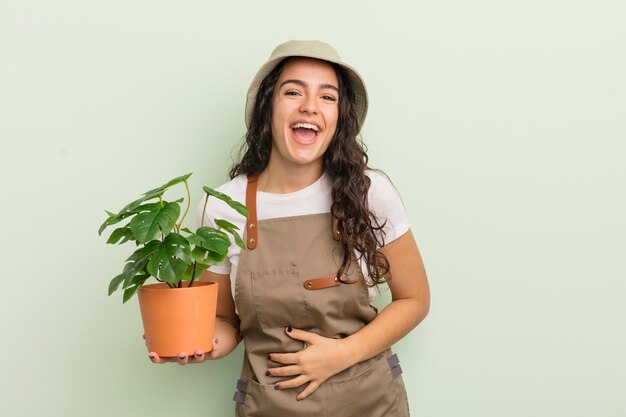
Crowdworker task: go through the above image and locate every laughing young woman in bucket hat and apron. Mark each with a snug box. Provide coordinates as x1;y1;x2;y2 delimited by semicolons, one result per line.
150;41;429;417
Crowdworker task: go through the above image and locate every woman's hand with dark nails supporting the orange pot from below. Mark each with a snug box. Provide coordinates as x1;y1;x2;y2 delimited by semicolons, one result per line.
144;317;239;365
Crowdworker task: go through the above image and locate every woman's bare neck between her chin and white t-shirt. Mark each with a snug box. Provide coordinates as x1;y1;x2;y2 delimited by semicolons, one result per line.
259;152;323;194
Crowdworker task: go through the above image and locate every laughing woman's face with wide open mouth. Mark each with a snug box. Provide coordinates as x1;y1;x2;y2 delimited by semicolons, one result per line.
271;58;339;169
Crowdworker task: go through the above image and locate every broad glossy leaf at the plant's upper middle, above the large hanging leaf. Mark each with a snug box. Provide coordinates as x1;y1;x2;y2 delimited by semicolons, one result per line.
130;203;180;243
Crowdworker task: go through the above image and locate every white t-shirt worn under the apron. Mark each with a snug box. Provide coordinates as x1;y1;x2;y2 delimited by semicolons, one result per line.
196;170;409;300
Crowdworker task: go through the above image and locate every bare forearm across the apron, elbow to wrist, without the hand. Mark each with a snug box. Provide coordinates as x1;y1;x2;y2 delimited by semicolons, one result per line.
344;298;428;363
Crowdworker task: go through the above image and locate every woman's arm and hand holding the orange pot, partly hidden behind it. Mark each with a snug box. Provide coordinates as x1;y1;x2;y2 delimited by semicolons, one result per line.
149;271;240;365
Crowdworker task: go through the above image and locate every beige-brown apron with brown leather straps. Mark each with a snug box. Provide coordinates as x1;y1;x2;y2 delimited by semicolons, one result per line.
234;177;409;417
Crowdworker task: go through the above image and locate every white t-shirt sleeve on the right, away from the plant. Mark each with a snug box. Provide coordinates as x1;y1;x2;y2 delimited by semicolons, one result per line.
367;171;411;244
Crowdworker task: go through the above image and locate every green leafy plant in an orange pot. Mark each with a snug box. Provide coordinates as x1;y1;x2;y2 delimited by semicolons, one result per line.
98;174;248;357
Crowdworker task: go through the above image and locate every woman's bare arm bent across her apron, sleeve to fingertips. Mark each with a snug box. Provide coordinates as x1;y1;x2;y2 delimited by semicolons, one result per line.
269;230;430;400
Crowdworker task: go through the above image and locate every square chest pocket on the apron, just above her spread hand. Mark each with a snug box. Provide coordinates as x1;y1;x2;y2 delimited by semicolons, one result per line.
250;267;313;332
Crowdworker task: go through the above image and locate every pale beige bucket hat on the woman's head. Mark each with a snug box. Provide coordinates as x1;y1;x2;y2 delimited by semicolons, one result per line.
246;40;367;130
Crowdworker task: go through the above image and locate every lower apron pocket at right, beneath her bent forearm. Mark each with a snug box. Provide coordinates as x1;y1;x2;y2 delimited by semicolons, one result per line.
322;354;404;417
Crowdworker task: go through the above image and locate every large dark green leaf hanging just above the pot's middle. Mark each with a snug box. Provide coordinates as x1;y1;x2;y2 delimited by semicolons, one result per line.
147;233;192;284
